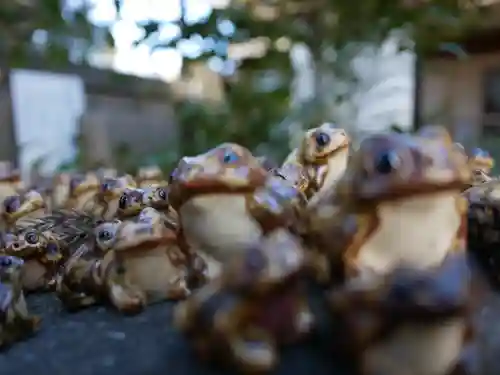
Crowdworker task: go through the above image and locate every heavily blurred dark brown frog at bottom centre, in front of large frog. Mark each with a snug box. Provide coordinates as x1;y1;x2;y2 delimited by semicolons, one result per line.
175;228;313;374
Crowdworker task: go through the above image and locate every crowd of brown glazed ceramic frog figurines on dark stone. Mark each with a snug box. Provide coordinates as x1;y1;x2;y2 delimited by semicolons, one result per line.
0;124;492;375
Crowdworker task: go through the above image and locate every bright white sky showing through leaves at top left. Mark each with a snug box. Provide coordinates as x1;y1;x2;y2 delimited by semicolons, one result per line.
75;0;221;81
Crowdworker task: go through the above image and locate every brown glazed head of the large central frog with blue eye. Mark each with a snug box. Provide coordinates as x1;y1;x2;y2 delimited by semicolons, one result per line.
169;143;267;210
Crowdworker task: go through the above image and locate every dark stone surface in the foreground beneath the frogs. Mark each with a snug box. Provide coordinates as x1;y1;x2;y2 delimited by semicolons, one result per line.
0;295;338;375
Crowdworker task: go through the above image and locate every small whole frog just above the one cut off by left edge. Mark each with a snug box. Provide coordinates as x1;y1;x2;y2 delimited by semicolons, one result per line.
2;228;64;292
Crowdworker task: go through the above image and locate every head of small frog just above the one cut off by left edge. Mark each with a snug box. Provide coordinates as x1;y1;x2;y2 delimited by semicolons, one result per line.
4;229;63;263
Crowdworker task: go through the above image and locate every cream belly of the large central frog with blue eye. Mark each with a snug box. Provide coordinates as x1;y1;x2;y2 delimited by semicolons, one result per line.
179;194;262;262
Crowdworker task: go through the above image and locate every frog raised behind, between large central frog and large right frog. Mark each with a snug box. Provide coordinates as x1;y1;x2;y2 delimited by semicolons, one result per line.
282;123;350;206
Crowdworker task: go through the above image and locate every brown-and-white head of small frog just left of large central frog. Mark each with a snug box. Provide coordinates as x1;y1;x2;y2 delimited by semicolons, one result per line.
113;222;176;252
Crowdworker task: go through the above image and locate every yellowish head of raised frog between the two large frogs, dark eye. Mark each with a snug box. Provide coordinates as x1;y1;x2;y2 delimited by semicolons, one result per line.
300;123;350;164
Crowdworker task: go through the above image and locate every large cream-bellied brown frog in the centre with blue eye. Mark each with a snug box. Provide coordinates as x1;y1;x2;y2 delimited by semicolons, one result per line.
168;143;298;277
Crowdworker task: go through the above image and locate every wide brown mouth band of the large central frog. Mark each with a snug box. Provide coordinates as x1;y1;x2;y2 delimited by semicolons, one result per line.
168;169;268;211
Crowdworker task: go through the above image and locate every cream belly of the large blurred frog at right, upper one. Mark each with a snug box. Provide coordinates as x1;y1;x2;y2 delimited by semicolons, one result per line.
357;193;461;275
